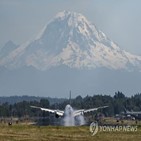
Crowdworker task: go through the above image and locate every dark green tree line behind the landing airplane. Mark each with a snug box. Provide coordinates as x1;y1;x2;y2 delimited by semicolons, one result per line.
0;92;141;118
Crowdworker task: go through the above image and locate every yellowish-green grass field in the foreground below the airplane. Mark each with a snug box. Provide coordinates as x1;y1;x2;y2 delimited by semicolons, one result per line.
0;124;141;141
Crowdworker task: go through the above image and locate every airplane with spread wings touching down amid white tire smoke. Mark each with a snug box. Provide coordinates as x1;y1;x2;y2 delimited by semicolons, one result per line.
30;92;109;118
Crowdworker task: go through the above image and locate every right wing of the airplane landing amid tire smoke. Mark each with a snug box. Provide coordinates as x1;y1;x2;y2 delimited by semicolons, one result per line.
74;106;109;116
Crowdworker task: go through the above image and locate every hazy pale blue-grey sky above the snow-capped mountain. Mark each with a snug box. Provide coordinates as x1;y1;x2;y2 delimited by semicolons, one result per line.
0;0;141;55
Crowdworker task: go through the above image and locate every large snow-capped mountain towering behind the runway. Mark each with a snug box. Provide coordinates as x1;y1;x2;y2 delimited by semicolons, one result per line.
0;11;141;71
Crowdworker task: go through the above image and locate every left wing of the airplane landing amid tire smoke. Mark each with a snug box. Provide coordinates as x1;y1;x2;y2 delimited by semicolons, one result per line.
30;106;64;116
